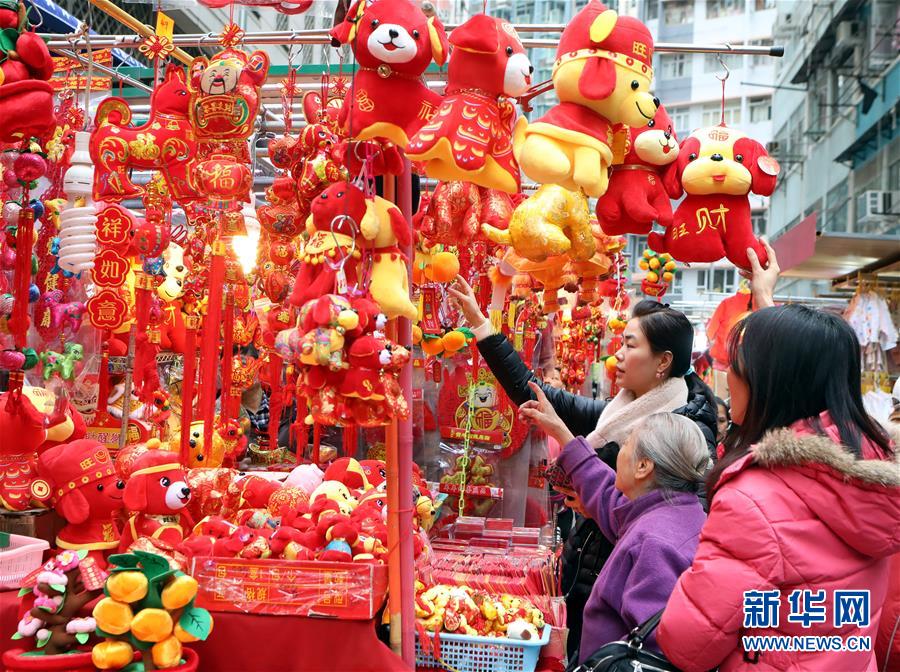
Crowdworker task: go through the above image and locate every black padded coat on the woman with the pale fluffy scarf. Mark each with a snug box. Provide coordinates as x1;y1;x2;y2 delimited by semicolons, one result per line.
478;334;717;659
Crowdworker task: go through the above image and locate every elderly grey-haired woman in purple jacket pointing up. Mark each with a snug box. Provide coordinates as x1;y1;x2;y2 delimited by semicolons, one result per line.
519;383;710;662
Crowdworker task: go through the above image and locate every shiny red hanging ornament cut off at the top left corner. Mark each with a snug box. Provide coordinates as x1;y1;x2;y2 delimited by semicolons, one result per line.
0;0;56;142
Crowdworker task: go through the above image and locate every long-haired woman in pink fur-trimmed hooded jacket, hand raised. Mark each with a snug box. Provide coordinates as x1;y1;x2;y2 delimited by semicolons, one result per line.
657;250;900;672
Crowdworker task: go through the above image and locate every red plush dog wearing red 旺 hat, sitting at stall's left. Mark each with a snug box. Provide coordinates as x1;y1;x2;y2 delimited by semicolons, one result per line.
31;439;125;567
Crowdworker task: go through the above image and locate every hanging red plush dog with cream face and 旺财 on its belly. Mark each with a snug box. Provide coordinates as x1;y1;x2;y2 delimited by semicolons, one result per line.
647;126;780;269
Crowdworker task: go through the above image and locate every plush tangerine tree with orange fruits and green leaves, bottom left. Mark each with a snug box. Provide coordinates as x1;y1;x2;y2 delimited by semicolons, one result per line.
92;551;212;672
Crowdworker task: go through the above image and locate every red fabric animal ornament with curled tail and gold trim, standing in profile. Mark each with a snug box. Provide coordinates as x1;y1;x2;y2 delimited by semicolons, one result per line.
91;64;200;202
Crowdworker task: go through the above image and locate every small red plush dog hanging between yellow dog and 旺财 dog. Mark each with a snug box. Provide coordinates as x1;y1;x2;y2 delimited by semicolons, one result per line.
597;106;680;236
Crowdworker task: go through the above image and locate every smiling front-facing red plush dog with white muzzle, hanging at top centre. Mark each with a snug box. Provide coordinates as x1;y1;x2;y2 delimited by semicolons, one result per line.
331;0;449;149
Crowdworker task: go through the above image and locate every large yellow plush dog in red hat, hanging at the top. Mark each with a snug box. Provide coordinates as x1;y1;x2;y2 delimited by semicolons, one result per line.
515;0;658;197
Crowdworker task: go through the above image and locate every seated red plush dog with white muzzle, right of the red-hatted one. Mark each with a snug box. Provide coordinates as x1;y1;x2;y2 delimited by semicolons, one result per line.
119;450;193;553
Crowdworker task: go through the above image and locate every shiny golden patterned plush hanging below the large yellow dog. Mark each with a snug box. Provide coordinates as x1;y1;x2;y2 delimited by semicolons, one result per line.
482;184;597;262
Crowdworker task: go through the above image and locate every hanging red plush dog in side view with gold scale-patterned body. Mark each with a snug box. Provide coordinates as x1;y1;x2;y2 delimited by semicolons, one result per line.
406;14;534;194
